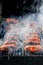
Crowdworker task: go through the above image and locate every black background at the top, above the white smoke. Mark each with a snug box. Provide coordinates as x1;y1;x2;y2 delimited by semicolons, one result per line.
2;0;41;17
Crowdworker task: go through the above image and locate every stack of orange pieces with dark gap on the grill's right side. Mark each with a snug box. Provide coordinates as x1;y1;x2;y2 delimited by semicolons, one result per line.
24;33;42;52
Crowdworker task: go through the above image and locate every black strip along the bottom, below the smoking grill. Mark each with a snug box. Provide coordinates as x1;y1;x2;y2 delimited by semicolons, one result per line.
0;56;43;65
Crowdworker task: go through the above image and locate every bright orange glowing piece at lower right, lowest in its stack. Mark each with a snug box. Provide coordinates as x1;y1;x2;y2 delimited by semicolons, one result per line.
24;45;42;52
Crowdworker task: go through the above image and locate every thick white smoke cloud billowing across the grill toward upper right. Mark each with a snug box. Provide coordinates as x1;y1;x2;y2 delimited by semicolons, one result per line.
0;0;43;54
